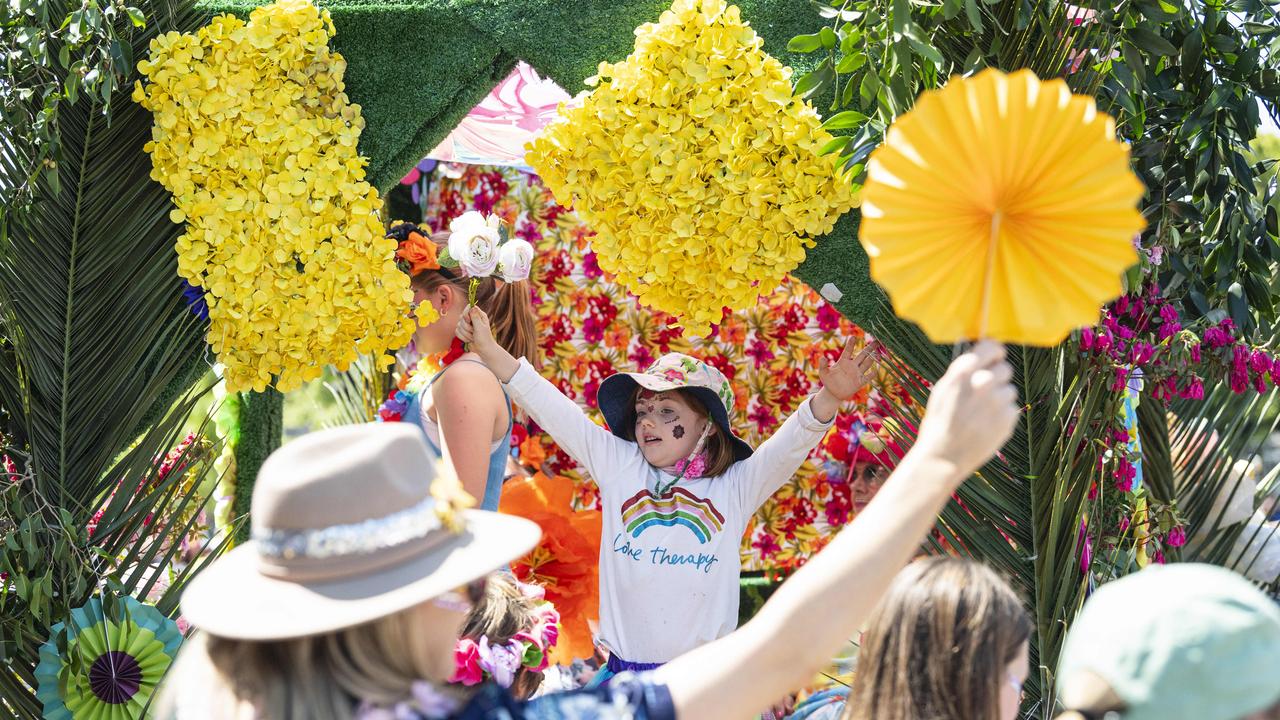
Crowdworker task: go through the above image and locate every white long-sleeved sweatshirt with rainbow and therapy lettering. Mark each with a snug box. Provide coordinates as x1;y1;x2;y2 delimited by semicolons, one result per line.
507;360;832;662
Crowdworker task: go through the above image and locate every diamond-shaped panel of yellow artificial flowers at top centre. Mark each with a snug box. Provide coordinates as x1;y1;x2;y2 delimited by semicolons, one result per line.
526;0;854;334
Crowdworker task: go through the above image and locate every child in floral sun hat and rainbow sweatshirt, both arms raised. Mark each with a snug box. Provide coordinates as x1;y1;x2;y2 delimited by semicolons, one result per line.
458;307;874;679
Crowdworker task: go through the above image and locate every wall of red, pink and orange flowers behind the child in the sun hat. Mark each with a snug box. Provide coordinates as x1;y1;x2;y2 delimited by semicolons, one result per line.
406;164;906;571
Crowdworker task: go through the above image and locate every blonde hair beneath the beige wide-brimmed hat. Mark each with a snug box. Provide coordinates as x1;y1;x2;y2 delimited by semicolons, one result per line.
156;606;465;720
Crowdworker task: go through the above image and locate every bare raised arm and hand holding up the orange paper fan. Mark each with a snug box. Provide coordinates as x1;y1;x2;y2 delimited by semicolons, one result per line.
654;341;1018;719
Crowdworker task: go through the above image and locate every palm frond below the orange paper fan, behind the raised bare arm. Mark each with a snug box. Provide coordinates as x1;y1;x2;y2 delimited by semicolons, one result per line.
868;295;1100;715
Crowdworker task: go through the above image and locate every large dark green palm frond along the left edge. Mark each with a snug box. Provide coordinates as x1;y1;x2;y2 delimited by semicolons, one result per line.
0;0;216;717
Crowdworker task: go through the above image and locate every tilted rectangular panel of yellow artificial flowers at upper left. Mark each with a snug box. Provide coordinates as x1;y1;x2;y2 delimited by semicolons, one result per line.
133;0;413;392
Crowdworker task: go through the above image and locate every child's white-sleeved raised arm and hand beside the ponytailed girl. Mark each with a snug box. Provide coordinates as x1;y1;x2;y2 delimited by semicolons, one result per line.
457;305;640;476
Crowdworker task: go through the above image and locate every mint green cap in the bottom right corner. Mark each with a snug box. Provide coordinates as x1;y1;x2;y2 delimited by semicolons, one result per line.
1057;564;1280;720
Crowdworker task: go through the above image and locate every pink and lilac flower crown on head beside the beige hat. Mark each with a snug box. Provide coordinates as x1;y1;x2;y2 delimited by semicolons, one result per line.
449;601;559;688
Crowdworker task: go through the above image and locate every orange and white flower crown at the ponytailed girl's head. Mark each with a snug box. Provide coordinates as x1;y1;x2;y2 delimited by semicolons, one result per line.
387;210;534;286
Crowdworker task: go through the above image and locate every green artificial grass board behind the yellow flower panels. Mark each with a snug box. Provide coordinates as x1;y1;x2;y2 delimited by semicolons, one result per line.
192;0;884;319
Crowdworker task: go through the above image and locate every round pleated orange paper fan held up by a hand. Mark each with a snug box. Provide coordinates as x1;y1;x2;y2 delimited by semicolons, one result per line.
860;69;1144;346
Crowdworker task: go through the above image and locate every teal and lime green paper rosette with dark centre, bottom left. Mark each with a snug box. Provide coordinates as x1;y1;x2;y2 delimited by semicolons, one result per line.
36;597;182;720
